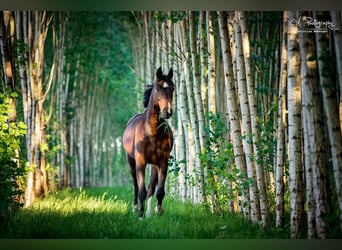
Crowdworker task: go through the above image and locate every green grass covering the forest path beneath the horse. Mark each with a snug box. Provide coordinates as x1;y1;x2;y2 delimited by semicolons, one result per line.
0;187;287;239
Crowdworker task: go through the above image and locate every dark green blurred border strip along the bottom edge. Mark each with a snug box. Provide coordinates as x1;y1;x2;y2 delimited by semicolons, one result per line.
0;239;341;250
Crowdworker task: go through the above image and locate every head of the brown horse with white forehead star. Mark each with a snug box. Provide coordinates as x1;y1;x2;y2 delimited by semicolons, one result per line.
152;67;174;119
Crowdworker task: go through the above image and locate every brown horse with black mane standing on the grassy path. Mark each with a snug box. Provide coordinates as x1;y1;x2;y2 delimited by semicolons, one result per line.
123;68;174;217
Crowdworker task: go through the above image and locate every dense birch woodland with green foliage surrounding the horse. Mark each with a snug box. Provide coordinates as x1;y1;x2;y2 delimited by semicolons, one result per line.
0;11;342;238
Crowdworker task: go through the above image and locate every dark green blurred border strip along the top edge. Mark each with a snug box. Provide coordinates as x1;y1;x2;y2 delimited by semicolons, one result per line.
0;0;342;11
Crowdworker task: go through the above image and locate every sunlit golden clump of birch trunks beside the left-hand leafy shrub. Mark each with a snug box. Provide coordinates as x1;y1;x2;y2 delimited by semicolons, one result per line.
16;11;56;206
